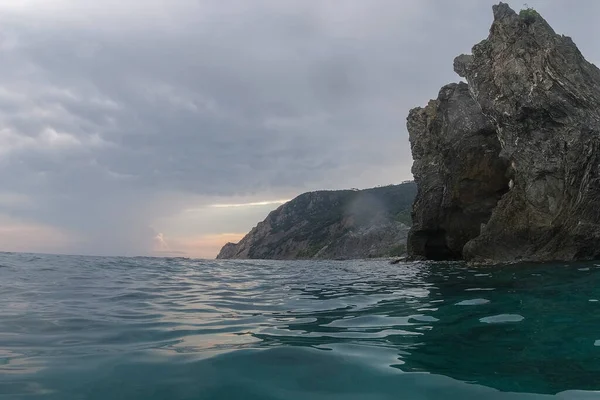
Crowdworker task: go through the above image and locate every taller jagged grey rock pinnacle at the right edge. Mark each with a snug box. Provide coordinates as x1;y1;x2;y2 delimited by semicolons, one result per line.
409;3;600;261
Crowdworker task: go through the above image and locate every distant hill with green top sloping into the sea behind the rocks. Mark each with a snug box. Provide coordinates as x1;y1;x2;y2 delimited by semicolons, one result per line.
217;182;417;259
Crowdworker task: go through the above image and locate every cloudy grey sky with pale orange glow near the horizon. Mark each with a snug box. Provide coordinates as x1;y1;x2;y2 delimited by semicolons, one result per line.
0;0;600;258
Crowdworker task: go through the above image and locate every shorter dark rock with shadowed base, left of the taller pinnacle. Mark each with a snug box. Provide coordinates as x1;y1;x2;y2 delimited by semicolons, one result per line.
407;83;508;260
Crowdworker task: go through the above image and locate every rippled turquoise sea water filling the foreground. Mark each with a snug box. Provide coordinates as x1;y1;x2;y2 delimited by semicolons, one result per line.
0;253;600;400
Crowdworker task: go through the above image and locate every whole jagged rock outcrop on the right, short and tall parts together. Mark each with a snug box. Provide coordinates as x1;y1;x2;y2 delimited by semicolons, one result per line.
408;3;600;261
